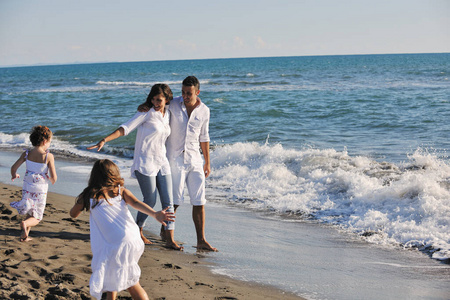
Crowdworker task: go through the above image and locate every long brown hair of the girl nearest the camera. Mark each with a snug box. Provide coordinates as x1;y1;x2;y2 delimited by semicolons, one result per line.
76;159;124;211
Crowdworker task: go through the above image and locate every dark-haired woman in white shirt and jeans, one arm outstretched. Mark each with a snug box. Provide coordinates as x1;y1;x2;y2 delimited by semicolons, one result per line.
87;84;183;250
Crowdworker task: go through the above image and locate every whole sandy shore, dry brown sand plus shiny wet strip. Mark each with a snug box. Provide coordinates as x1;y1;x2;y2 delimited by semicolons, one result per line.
0;151;450;299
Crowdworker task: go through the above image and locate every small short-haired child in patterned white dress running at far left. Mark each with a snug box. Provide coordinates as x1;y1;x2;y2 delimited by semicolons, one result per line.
11;126;57;242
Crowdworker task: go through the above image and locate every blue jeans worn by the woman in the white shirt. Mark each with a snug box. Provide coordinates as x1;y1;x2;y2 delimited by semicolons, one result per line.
134;171;175;230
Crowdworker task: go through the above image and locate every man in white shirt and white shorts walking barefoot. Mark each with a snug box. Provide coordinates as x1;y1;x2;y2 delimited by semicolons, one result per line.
142;76;217;251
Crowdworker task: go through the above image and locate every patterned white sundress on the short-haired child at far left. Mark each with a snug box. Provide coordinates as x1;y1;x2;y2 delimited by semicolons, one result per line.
11;150;48;220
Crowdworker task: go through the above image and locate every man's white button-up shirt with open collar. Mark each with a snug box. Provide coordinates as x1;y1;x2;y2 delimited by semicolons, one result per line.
166;96;210;164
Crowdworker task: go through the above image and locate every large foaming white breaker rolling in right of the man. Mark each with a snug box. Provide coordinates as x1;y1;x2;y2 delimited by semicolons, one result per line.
210;143;450;259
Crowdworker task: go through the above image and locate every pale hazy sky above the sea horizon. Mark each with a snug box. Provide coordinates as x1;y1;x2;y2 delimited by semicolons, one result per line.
0;0;450;66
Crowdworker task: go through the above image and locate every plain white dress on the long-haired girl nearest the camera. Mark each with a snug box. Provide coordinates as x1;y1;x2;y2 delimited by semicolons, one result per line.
89;191;145;299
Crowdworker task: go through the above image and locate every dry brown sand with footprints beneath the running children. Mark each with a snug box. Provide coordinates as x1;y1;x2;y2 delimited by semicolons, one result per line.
0;183;302;300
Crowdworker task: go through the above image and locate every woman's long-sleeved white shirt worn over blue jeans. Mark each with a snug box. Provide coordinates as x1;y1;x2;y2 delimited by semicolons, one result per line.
120;107;170;178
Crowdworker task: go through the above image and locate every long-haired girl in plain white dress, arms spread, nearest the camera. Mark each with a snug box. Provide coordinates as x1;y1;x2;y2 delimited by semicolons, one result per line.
70;159;175;299
